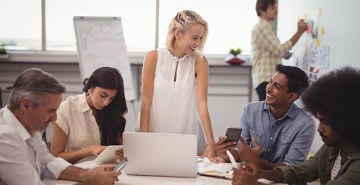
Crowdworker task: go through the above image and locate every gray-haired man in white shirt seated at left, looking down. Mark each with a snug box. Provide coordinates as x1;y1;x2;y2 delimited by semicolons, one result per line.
0;68;120;185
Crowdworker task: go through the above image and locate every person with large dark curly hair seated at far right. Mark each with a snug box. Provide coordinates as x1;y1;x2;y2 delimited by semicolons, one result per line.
232;67;360;185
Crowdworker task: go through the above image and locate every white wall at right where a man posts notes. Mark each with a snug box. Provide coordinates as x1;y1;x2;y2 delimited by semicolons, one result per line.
277;0;360;152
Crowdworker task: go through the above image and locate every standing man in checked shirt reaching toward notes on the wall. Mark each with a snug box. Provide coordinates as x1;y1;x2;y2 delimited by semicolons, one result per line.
251;0;307;101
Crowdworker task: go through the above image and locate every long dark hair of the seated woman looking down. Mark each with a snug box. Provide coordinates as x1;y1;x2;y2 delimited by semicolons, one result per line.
83;67;128;146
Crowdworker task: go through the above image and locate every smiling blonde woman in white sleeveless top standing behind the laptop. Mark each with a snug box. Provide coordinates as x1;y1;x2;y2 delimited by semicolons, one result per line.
138;10;216;161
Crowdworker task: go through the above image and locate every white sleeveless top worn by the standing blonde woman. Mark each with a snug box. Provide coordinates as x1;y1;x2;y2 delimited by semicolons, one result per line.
138;48;197;134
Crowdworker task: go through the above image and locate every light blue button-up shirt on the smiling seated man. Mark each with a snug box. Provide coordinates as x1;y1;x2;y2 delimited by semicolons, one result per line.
240;101;315;165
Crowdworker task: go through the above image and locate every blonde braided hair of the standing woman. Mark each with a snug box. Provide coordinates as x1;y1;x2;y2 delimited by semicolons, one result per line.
165;10;208;62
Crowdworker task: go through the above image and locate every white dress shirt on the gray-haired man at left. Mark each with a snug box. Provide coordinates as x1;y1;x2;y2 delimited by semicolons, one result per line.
0;107;71;185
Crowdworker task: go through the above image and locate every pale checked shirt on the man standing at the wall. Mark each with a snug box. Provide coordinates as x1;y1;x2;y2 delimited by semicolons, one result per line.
251;18;292;87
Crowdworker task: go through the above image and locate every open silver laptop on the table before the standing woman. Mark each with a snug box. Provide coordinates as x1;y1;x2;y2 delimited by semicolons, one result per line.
123;132;197;177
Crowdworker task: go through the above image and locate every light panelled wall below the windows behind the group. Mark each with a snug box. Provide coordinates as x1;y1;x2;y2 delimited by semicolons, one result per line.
0;56;257;146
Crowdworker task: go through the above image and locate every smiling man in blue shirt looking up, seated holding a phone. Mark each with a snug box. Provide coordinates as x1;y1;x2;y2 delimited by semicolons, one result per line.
217;64;315;169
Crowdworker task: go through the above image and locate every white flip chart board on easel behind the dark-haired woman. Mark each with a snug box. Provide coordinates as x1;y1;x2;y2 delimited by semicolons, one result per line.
74;16;135;101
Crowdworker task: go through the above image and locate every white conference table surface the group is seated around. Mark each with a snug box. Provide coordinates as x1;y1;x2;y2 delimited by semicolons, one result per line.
43;161;285;185
